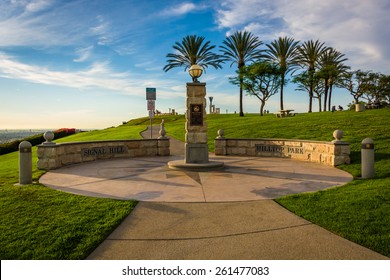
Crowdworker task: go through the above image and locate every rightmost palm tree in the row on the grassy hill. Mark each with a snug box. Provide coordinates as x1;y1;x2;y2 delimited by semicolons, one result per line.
319;48;349;111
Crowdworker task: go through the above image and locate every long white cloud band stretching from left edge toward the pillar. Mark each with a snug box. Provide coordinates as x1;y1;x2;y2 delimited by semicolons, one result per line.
0;53;184;98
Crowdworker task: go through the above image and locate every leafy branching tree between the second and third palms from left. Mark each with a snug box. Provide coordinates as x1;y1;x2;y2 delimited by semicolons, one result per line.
231;61;281;116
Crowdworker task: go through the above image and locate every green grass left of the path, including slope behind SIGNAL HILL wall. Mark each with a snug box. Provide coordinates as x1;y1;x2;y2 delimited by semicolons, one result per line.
0;124;146;260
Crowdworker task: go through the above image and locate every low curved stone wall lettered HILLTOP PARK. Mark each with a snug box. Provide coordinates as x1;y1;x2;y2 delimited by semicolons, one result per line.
215;137;350;166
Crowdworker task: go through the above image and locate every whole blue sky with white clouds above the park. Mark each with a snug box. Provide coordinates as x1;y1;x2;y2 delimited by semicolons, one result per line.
0;0;390;129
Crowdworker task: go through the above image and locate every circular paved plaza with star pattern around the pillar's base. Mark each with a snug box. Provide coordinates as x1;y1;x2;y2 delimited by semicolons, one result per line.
40;156;352;202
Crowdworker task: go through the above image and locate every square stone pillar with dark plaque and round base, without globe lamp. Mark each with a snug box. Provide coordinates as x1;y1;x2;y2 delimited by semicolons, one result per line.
168;82;223;171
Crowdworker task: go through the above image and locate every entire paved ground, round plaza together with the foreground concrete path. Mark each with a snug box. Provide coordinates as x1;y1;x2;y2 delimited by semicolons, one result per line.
40;128;385;259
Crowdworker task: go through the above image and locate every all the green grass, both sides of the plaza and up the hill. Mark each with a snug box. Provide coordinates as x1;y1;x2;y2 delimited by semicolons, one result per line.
0;109;390;259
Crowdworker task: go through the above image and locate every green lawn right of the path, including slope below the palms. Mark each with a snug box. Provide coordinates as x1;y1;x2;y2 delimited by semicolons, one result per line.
160;108;390;257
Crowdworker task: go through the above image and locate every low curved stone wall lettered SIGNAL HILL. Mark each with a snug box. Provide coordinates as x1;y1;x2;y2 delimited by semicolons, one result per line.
37;138;170;170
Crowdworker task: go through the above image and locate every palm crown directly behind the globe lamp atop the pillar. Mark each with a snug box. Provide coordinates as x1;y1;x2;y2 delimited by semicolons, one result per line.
163;35;223;81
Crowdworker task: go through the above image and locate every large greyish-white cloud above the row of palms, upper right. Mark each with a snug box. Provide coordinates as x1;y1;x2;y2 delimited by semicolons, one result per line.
216;0;390;73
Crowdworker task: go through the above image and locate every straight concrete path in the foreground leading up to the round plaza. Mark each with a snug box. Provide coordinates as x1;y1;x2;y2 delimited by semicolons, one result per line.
88;200;385;260
